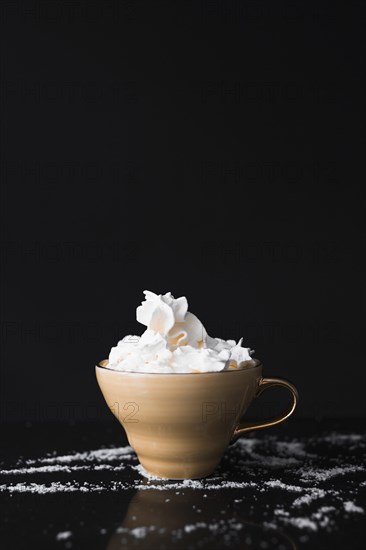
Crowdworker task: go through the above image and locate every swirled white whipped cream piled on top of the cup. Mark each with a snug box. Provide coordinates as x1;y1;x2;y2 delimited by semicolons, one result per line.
108;290;255;373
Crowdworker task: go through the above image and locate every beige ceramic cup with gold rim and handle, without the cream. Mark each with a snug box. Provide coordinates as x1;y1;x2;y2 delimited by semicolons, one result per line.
96;360;298;479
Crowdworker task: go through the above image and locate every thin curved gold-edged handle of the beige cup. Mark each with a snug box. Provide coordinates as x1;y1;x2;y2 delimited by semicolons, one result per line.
230;378;299;445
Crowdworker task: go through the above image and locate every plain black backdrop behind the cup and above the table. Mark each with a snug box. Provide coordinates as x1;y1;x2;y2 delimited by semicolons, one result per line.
1;0;365;421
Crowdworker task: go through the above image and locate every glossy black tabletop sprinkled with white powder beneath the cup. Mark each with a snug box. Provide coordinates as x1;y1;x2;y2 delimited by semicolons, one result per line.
0;418;366;550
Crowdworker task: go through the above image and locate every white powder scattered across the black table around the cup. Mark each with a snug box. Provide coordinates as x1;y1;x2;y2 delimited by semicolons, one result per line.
0;433;366;544
